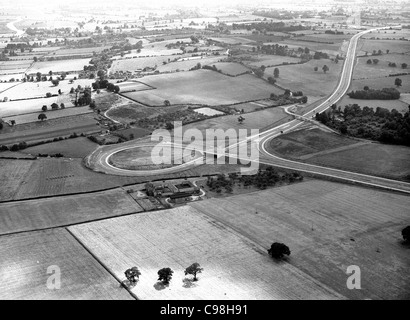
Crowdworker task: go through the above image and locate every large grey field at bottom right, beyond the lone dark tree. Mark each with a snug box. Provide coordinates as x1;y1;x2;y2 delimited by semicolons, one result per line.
189;180;410;300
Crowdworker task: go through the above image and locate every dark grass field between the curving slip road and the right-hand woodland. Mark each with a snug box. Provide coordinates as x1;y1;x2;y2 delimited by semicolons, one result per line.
268;129;410;179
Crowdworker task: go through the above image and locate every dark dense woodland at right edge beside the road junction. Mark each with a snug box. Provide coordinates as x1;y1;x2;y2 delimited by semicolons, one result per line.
316;104;410;146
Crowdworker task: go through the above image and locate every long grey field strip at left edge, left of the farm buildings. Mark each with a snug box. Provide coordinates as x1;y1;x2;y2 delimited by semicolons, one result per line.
0;189;143;234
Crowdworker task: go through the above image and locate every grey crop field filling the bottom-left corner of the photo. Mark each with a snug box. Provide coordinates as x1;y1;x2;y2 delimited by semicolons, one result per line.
0;229;132;300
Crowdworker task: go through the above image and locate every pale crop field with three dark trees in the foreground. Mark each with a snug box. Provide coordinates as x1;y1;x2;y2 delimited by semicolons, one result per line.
69;206;340;300
